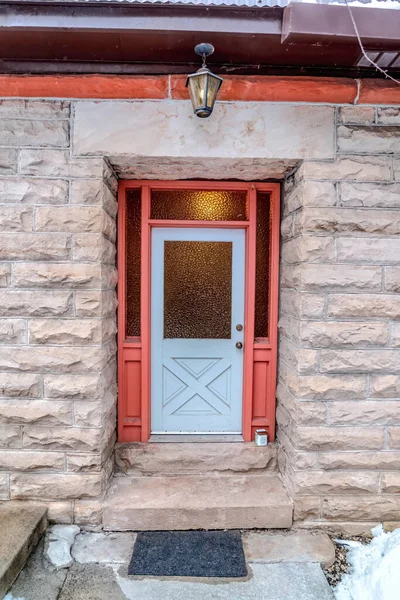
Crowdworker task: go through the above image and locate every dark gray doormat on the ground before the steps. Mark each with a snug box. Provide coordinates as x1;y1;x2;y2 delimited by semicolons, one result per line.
128;531;247;577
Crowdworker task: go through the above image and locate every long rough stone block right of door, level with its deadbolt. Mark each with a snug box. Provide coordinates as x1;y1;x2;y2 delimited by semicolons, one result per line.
300;321;388;348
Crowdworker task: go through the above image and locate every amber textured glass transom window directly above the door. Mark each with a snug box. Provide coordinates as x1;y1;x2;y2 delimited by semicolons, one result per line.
150;190;248;221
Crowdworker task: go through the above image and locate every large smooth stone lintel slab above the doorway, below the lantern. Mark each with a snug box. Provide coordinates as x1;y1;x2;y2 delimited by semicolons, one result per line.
73;101;334;160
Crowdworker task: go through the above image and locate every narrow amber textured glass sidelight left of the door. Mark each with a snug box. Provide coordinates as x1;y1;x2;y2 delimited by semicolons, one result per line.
125;189;142;337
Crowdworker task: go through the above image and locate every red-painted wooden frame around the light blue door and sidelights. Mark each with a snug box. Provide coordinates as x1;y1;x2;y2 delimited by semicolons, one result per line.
118;180;280;442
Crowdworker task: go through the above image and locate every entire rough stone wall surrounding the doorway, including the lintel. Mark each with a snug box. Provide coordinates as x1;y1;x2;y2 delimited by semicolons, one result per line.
0;91;400;527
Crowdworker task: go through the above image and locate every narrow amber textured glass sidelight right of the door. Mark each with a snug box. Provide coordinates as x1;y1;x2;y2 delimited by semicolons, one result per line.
254;192;271;338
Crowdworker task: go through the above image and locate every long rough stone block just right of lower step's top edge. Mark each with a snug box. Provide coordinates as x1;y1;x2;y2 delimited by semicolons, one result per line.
291;471;379;496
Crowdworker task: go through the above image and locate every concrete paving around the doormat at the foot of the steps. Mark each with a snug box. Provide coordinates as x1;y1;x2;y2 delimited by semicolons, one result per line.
7;532;334;600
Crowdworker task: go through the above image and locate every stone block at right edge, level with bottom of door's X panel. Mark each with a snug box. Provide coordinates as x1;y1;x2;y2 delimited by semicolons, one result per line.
328;398;400;425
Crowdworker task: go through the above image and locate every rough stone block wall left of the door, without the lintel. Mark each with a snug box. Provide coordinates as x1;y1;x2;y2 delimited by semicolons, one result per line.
0;100;117;523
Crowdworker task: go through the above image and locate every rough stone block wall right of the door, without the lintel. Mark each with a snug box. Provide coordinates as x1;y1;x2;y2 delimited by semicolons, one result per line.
277;106;400;531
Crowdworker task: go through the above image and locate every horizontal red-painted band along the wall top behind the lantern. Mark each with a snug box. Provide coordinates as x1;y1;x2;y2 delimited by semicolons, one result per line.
0;75;400;104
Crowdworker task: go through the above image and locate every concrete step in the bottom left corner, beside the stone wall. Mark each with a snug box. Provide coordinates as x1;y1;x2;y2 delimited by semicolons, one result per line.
0;502;47;599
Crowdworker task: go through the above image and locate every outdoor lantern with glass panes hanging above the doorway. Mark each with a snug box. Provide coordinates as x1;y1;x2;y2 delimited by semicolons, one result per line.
186;44;223;119
